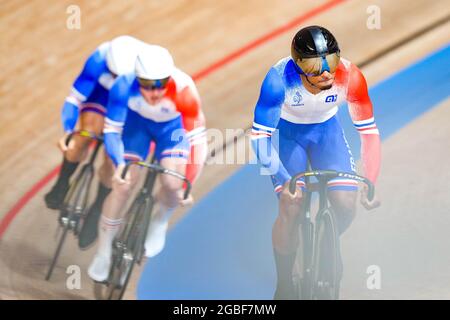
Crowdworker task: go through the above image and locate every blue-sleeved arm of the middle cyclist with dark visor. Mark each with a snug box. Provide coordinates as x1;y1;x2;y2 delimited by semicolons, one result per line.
103;76;129;166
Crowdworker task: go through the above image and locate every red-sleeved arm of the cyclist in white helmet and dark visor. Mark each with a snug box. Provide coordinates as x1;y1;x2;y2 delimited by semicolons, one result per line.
176;83;207;183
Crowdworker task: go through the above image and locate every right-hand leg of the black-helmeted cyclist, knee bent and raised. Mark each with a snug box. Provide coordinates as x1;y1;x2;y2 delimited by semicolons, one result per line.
308;116;358;234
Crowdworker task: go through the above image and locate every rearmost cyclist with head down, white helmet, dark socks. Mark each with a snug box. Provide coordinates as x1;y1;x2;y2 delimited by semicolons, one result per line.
44;36;143;214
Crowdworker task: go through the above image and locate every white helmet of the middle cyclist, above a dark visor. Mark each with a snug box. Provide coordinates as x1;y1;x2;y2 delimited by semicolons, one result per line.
135;45;175;80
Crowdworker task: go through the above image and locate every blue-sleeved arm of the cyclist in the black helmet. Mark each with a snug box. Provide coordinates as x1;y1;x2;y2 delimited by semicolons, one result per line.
251;68;291;185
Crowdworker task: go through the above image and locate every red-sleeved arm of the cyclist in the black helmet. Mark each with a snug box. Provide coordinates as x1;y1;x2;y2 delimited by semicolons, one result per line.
347;65;381;183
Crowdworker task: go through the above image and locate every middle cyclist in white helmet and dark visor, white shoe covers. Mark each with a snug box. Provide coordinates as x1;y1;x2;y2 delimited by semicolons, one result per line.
88;45;206;282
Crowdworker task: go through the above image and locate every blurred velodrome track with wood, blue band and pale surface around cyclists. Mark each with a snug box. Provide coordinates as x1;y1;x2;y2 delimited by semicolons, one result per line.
0;0;450;299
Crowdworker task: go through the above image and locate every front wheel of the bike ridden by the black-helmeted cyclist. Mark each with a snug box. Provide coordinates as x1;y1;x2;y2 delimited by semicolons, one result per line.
313;208;341;300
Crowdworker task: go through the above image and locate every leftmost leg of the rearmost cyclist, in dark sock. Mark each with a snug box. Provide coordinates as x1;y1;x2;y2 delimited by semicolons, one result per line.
45;102;105;209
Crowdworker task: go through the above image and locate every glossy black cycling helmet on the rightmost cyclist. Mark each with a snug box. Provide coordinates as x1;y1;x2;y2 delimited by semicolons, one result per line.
291;26;340;61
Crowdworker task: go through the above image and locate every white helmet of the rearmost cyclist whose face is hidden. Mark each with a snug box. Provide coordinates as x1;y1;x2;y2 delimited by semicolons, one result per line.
106;36;143;76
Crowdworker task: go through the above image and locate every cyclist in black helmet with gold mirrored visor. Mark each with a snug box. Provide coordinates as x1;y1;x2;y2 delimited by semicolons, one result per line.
251;26;381;299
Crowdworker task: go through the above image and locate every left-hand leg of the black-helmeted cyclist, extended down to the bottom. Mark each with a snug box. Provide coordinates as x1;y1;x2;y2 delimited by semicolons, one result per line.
272;126;307;299
